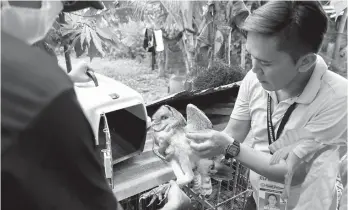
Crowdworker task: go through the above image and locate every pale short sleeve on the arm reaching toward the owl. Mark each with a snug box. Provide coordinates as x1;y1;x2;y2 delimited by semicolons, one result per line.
231;71;251;120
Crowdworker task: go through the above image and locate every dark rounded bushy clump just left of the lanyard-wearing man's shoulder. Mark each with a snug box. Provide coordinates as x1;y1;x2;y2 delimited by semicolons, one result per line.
193;60;245;90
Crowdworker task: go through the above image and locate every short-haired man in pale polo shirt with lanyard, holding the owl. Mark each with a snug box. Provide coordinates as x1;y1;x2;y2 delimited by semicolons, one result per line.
187;1;347;210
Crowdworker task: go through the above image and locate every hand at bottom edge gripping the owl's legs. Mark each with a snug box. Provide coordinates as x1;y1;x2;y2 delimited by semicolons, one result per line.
161;180;191;210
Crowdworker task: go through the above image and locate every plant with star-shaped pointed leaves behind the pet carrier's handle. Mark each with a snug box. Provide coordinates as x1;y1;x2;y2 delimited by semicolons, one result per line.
45;1;137;61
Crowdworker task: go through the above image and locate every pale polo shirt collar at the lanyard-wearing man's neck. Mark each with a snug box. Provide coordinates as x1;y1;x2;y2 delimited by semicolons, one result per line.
296;55;328;104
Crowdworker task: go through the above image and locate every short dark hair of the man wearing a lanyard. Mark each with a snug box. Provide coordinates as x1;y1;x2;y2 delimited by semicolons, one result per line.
242;0;328;62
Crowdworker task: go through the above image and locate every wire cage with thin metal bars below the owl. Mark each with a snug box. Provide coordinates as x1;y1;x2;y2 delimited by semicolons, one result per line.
120;160;252;210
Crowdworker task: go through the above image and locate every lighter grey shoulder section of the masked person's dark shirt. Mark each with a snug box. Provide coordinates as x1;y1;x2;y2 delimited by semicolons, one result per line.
1;32;73;143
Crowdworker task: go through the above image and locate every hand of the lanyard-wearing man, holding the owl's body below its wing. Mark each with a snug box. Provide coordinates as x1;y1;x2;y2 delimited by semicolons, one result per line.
186;130;234;158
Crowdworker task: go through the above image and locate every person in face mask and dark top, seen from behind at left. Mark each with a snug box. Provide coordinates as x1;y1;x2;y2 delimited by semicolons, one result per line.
1;0;189;210
